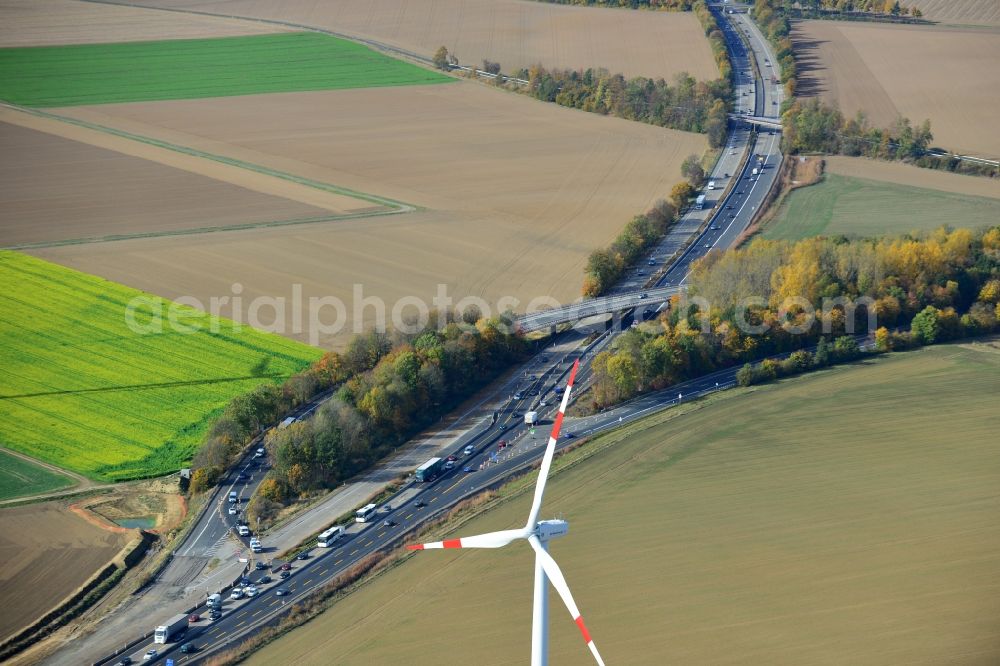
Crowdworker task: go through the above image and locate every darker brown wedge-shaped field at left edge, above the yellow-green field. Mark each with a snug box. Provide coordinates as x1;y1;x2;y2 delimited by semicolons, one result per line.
0;123;350;247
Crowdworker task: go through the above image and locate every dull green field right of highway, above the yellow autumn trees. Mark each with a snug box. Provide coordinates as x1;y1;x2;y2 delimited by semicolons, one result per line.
762;173;1000;240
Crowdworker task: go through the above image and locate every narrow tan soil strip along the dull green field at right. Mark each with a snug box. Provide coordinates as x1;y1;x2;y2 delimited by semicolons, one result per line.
823;155;1000;199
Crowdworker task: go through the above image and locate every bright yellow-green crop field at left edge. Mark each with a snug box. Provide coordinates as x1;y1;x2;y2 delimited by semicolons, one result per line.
0;252;322;480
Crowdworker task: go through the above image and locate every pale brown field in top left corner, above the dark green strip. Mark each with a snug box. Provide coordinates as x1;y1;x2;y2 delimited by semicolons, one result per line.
0;0;287;47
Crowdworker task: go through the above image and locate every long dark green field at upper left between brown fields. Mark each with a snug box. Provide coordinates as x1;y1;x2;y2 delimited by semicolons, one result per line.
0;32;453;107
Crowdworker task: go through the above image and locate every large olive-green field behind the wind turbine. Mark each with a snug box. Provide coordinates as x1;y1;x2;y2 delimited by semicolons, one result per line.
248;341;1000;666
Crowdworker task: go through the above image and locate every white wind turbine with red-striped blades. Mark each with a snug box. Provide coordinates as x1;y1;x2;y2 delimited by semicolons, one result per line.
407;360;604;666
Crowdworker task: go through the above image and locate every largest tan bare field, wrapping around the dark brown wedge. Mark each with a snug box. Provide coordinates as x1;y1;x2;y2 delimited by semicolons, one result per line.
45;82;706;345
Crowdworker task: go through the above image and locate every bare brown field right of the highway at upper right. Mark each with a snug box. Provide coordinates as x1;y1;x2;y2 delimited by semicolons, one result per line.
792;21;1000;158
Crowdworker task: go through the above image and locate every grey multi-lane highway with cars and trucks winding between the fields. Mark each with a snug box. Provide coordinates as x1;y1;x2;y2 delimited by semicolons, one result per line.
86;2;781;664
